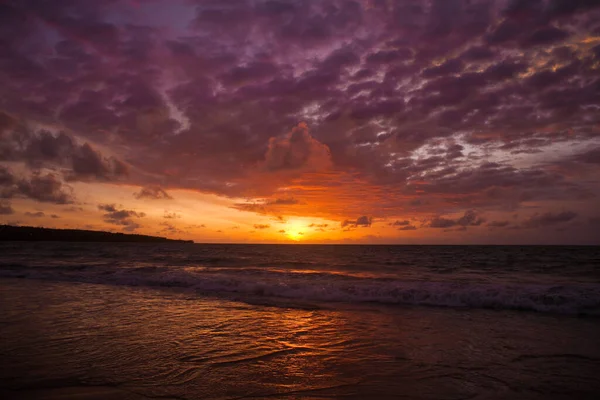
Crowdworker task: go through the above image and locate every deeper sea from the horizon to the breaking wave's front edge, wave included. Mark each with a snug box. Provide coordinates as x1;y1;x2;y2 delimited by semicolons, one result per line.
0;243;600;315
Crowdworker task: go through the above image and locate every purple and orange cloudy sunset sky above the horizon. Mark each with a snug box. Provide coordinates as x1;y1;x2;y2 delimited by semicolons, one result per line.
0;0;600;244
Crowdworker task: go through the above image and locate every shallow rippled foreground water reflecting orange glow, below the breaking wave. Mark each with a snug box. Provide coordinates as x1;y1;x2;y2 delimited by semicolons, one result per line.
0;279;600;399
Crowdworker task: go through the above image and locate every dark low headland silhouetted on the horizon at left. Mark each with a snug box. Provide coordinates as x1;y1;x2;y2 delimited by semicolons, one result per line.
0;225;194;243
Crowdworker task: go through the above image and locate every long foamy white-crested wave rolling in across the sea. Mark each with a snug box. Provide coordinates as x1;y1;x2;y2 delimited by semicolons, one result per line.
0;264;600;316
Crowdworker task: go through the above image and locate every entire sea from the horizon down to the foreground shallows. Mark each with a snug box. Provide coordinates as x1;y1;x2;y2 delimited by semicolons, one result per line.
0;242;600;399
